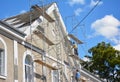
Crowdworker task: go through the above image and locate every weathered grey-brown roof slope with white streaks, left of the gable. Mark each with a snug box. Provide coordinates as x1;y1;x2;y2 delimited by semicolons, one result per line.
3;10;40;29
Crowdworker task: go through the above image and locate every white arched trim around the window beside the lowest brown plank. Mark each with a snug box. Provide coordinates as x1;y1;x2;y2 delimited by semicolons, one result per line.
23;50;36;82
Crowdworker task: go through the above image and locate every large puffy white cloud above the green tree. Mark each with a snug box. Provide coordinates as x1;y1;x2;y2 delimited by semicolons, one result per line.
91;15;120;44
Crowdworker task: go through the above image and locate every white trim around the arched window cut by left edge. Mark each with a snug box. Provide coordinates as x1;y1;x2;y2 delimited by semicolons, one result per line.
0;37;7;79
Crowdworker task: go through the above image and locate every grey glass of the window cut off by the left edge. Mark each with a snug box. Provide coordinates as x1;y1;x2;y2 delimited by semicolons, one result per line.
0;49;5;76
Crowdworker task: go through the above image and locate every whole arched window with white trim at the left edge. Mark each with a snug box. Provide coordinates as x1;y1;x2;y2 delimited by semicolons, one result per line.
0;38;7;77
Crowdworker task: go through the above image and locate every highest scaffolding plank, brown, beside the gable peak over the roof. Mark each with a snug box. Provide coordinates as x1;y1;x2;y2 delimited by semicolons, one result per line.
32;5;55;22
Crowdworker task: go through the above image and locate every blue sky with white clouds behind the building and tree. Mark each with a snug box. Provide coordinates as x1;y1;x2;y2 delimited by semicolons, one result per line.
0;0;120;58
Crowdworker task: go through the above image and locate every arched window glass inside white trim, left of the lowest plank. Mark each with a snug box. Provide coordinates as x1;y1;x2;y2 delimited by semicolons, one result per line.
25;55;34;82
